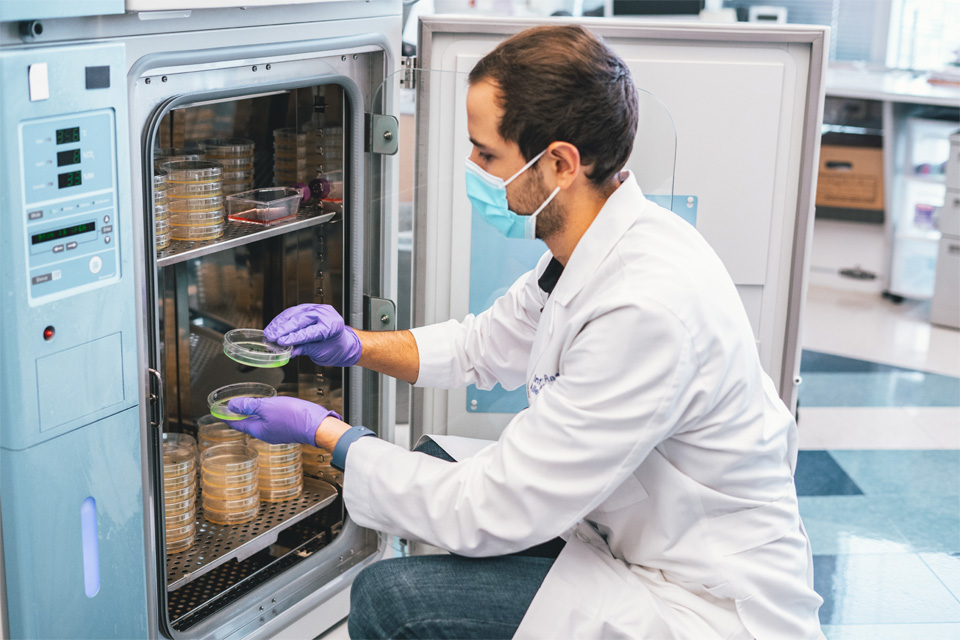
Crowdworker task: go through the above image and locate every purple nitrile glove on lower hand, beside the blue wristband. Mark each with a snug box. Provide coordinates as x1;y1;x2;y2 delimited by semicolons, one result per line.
227;396;343;447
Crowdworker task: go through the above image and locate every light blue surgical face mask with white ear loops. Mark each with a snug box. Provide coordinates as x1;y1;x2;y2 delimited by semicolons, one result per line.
466;149;560;240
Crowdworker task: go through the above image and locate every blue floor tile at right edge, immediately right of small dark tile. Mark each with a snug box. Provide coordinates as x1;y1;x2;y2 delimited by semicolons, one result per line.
830;450;960;496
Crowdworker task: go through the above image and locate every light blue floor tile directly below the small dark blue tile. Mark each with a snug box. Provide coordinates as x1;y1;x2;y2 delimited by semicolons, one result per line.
800;496;914;555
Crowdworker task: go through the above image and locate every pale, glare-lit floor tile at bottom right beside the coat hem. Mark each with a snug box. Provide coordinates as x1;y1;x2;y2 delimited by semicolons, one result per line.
814;553;960;624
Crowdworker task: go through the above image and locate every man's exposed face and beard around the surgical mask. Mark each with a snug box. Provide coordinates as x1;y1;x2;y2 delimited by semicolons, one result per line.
467;80;563;238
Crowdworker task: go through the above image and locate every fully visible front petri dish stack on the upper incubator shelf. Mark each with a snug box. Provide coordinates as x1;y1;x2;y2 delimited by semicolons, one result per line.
163;160;224;240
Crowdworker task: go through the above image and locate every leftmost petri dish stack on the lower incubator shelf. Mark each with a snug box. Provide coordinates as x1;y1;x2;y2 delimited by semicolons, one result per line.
163;437;197;553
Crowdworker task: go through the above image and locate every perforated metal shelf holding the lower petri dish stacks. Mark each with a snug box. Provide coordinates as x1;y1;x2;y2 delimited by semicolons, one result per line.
167;478;337;591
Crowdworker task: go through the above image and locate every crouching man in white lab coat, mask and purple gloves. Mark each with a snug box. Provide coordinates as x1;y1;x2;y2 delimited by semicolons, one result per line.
230;26;822;640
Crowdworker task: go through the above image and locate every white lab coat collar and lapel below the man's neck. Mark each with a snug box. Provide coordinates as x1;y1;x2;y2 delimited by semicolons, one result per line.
552;172;647;306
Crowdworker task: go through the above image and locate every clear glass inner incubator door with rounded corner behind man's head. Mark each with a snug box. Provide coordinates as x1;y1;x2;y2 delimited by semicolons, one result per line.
368;66;676;443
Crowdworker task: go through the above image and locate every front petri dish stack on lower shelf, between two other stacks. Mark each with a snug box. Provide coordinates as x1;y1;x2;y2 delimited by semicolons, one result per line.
200;444;260;525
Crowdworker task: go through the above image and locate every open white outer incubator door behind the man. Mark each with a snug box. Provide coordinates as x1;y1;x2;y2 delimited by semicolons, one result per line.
402;17;825;442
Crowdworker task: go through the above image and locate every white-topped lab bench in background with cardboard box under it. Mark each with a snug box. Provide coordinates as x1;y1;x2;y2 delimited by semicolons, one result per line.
817;65;960;300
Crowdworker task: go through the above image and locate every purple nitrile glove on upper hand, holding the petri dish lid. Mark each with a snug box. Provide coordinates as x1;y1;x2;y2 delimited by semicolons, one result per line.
263;304;363;367
